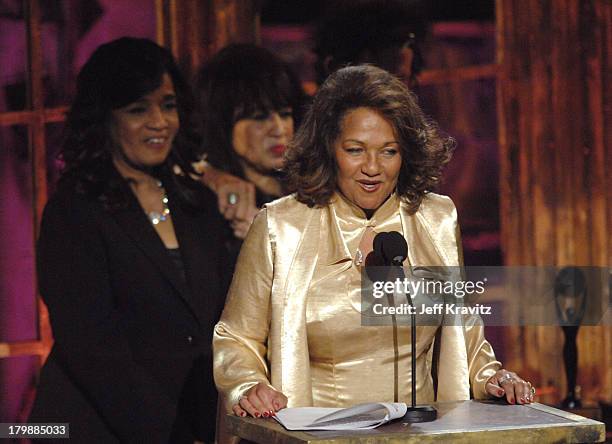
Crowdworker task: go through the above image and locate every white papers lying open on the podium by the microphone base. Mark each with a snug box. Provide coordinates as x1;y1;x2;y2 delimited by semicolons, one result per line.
274;402;407;430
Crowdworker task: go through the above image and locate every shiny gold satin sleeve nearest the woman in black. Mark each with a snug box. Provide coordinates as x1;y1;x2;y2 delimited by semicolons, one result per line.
213;209;273;411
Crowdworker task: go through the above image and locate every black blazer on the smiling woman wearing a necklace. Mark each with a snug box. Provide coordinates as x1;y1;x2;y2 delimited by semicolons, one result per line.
29;172;229;443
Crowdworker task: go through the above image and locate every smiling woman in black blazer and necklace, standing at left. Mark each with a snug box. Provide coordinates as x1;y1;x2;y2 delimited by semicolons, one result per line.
30;38;227;443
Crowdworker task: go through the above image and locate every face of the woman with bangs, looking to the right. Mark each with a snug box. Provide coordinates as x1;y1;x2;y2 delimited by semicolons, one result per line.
232;108;293;172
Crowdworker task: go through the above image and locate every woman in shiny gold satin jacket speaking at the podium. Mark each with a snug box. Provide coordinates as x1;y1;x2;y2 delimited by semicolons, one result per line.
213;66;533;417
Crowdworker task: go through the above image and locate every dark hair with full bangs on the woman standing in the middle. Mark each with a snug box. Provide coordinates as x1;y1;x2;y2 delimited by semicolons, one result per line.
196;44;306;177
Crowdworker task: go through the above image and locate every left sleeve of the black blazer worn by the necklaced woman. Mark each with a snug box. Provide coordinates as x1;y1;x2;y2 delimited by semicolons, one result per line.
37;199;176;443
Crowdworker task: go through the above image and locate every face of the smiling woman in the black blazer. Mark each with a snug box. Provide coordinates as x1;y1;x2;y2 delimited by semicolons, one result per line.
111;74;179;167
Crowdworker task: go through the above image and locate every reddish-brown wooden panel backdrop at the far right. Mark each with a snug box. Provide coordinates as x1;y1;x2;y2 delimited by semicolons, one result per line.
497;0;612;402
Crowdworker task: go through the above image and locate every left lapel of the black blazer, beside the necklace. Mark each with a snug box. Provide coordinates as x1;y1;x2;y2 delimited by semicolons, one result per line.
111;173;193;322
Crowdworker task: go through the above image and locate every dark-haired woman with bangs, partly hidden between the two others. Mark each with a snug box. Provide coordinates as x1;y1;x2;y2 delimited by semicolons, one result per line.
197;44;305;245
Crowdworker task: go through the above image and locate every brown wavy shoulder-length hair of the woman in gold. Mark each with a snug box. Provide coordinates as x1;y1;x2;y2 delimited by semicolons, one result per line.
285;65;454;212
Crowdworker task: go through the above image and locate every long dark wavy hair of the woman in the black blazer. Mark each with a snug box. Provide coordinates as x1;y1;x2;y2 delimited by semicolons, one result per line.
59;37;199;209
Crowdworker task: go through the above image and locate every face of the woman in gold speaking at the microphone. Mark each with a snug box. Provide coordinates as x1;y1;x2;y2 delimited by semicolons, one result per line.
334;108;402;210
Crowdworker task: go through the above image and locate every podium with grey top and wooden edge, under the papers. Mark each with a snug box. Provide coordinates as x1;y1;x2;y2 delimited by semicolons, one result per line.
227;401;606;444
